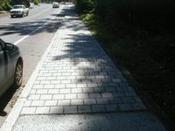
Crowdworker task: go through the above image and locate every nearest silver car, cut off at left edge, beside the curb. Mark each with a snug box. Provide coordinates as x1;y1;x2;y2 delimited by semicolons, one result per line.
0;39;23;96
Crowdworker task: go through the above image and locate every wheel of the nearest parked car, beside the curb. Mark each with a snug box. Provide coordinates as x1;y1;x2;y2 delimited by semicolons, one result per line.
14;60;23;88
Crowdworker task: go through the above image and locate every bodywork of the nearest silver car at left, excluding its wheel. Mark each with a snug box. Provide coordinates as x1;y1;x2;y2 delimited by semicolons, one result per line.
0;39;22;96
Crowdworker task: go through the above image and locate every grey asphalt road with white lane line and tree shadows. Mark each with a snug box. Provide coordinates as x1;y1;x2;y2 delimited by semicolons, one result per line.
0;4;61;126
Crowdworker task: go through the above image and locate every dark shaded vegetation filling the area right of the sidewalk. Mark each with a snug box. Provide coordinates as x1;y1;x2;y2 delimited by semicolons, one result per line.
76;0;175;122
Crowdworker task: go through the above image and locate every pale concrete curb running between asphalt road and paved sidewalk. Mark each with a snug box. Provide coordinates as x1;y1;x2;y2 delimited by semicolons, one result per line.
0;20;59;131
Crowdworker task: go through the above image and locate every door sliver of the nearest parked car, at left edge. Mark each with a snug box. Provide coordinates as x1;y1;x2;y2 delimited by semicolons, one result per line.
0;40;7;92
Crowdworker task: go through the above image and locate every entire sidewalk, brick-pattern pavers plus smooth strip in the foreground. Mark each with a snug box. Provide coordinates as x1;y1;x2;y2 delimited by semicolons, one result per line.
1;5;164;131
